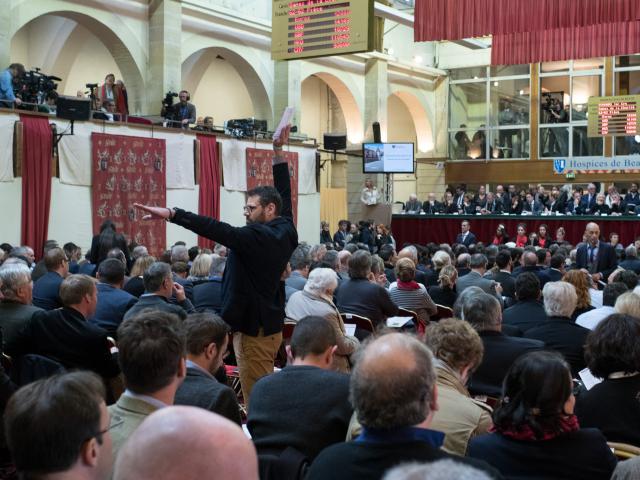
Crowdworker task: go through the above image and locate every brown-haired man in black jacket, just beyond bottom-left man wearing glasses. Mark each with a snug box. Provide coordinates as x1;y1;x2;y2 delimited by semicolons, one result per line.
7;274;120;378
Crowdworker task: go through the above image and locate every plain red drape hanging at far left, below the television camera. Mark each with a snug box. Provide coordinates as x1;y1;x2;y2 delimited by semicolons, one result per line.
20;115;53;259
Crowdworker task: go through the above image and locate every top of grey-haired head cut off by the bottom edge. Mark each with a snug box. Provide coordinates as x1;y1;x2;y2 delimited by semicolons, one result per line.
382;459;491;480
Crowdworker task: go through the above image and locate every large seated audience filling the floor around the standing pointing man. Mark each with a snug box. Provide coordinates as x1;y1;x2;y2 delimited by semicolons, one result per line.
6;217;640;479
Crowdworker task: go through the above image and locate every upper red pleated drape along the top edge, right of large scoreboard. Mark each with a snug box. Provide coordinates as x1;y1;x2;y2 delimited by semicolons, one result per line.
414;0;640;42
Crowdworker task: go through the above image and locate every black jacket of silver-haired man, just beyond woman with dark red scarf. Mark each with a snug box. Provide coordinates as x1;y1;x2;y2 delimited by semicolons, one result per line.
524;317;591;377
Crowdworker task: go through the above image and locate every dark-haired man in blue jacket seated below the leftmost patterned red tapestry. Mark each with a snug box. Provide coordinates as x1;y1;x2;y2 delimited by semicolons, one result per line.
89;258;138;337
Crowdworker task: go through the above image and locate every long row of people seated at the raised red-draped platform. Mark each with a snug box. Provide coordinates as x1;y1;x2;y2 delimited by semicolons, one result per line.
392;183;640;216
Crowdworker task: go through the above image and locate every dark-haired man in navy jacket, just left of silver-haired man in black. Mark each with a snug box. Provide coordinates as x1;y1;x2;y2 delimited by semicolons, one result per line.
502;272;547;332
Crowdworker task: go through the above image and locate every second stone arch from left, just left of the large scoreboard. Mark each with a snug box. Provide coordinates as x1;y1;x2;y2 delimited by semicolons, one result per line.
182;46;273;127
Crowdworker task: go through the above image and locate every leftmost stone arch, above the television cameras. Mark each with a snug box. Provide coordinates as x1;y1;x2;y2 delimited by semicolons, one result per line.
11;7;147;113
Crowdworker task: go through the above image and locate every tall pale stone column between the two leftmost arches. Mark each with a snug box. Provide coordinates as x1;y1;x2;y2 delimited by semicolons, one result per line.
145;0;181;114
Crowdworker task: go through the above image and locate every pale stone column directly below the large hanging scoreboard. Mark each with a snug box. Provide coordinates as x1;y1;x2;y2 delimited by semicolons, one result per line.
269;60;304;133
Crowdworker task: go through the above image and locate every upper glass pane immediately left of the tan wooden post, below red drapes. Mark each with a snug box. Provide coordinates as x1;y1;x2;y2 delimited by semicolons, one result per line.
489;78;529;126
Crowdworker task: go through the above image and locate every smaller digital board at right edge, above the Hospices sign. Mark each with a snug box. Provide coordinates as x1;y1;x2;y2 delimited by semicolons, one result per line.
587;95;640;137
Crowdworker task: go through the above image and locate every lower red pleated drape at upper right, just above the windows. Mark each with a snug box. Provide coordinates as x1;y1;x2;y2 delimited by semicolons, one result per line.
491;21;640;65
